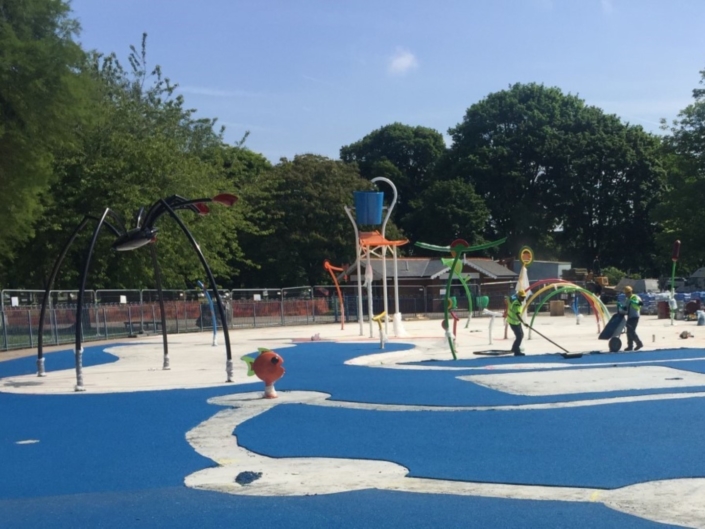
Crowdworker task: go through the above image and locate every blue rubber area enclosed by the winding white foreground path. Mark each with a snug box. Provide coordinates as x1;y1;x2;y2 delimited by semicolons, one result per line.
237;399;705;489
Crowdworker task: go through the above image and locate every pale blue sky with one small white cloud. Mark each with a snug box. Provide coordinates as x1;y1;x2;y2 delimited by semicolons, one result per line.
71;0;705;163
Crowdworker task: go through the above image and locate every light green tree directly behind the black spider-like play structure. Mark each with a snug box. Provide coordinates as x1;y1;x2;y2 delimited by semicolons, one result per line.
6;36;248;288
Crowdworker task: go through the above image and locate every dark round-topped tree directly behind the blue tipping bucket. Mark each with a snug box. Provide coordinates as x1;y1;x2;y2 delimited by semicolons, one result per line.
340;123;446;238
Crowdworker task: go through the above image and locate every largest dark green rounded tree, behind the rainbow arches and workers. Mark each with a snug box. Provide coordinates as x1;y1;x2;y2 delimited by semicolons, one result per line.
446;83;663;269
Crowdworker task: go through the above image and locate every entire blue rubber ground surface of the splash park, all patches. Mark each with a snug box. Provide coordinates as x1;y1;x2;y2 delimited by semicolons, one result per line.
0;342;705;529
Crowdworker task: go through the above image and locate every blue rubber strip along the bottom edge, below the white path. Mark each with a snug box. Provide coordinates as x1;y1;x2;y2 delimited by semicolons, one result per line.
0;487;672;529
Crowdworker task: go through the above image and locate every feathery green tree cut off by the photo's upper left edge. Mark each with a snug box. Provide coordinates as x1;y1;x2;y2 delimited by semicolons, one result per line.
0;0;86;264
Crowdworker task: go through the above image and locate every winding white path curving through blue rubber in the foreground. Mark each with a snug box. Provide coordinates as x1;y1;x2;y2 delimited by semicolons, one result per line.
184;391;705;528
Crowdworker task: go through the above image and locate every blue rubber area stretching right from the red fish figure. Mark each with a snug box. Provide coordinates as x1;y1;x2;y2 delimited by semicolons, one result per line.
277;342;705;406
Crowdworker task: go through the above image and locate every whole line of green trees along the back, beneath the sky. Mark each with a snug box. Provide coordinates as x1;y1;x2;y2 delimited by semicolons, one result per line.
0;0;705;288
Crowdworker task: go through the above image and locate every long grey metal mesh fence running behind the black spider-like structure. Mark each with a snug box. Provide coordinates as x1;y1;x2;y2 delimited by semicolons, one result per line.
0;283;513;351
